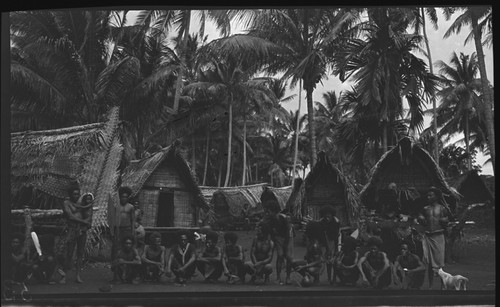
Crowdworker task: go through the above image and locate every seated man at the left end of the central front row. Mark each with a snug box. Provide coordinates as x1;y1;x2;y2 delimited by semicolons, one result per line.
111;236;141;284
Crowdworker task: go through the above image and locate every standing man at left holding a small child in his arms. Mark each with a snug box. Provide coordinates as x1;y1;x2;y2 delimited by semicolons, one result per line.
59;186;94;283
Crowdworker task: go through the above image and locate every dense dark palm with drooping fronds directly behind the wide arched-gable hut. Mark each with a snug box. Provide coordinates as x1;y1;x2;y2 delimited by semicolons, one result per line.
335;8;436;152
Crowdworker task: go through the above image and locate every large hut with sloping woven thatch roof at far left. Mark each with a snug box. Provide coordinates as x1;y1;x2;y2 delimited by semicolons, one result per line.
11;107;123;249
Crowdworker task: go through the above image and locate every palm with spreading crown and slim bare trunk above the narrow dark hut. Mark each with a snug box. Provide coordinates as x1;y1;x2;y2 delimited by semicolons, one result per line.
248;9;357;166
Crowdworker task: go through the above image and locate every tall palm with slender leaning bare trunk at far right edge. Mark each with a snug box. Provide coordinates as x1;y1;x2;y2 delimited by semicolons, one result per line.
444;6;495;172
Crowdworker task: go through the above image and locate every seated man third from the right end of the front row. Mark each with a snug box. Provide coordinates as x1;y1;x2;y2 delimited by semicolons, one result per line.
333;236;359;286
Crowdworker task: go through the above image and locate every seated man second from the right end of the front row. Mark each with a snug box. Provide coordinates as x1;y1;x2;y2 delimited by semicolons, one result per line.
358;237;391;289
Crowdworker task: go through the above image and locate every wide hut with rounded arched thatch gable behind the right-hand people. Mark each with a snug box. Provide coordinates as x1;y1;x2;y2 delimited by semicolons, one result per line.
360;137;460;213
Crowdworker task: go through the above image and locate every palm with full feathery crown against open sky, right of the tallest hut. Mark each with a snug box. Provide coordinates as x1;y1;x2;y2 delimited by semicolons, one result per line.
436;52;484;170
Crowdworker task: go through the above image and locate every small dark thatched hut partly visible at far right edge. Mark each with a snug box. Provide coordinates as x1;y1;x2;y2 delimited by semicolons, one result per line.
448;170;494;205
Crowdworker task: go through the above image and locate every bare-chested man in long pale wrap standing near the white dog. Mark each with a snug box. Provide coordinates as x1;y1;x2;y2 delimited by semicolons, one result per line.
418;187;451;288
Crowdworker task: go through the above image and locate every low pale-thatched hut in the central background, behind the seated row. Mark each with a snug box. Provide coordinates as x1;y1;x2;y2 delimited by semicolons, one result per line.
211;183;266;228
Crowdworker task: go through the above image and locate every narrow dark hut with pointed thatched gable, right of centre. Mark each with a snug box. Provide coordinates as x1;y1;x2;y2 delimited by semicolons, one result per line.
302;151;359;226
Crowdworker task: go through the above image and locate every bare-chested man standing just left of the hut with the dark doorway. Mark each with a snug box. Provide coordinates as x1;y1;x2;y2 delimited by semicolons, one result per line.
112;187;136;259
